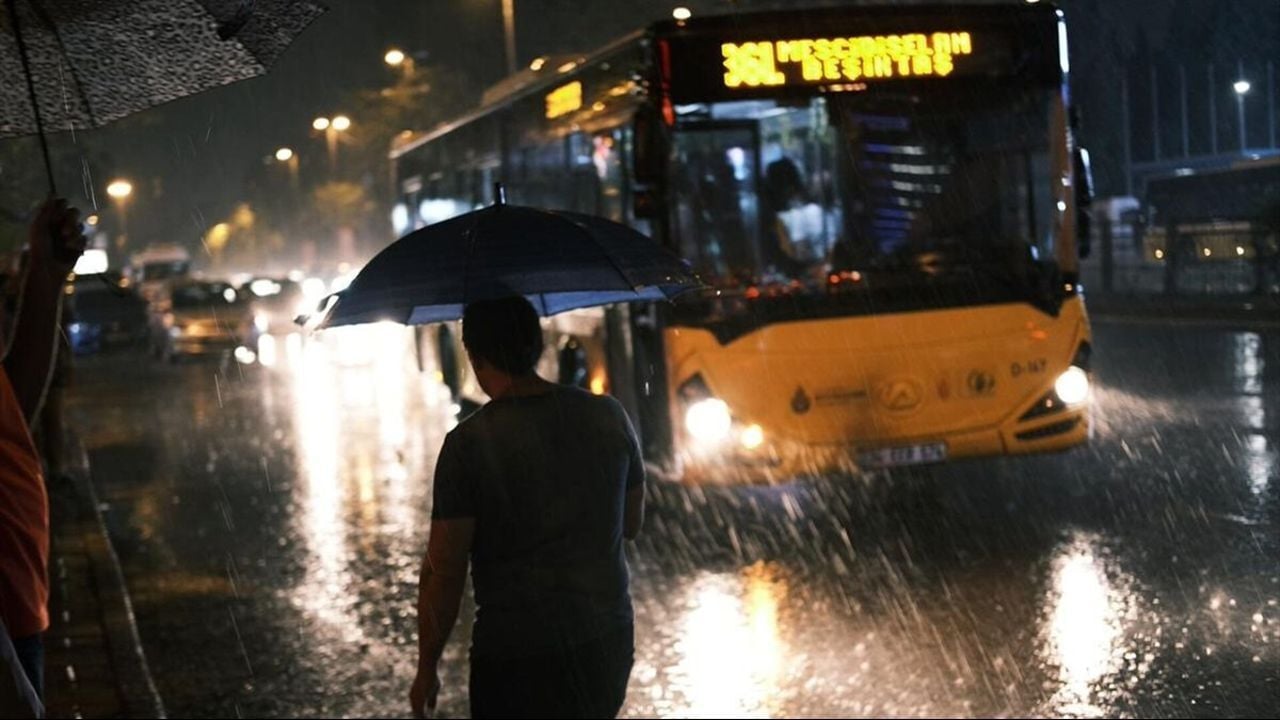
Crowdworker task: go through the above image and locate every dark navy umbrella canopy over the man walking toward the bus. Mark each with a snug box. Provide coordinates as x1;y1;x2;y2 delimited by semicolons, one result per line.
319;190;701;327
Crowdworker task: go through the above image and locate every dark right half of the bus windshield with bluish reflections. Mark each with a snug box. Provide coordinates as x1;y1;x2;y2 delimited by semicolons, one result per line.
837;92;1055;265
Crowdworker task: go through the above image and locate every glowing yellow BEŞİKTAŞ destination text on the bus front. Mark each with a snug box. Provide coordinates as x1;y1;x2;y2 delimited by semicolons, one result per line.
721;32;975;90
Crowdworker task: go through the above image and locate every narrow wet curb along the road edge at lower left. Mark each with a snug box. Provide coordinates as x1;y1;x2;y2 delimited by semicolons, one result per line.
67;433;166;719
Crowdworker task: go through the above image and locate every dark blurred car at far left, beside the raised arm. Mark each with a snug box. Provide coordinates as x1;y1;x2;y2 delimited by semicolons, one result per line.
64;273;148;355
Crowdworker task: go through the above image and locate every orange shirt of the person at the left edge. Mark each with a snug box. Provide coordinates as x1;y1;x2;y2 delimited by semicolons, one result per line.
0;365;49;638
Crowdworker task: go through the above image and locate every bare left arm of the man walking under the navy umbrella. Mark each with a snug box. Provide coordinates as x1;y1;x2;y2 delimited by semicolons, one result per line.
410;518;476;717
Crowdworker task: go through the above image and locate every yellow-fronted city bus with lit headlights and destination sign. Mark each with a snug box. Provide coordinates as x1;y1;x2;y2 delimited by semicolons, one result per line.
392;4;1091;482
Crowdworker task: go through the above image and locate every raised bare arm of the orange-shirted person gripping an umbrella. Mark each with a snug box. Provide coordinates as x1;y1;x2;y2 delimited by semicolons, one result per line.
4;200;84;424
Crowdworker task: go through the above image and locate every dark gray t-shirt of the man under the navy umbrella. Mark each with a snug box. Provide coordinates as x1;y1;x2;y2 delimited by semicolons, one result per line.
431;387;644;657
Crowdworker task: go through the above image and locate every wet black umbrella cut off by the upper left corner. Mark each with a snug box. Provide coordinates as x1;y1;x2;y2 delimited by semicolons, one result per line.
0;0;325;190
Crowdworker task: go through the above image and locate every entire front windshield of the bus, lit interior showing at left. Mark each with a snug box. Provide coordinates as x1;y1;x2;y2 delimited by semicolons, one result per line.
672;85;1059;288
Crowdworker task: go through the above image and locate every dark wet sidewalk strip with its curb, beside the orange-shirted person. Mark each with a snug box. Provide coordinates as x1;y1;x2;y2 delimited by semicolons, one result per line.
45;436;164;717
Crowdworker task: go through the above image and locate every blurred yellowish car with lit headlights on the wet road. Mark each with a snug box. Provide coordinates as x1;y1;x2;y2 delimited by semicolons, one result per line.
151;281;252;361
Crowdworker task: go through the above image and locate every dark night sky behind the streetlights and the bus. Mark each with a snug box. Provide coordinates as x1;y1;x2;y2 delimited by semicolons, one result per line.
5;0;1280;254
